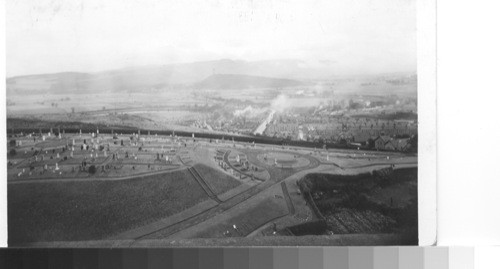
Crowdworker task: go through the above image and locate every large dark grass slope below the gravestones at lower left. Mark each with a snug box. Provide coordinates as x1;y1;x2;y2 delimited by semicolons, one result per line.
8;170;208;244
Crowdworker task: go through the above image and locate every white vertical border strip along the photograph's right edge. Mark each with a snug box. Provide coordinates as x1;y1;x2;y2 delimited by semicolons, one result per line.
417;0;437;246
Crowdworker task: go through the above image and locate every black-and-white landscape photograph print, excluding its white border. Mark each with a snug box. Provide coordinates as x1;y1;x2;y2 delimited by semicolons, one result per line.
4;0;426;247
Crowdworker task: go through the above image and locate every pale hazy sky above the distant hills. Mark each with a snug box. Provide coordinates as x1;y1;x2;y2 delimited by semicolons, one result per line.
6;0;416;77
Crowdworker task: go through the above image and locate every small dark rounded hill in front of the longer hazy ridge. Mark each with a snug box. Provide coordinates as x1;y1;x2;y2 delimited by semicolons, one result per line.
194;74;302;89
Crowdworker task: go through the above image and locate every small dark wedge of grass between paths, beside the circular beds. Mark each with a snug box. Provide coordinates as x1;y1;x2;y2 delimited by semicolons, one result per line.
194;164;241;195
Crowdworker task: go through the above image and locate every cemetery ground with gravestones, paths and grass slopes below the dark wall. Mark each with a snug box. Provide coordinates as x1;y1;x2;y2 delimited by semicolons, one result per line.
8;131;417;245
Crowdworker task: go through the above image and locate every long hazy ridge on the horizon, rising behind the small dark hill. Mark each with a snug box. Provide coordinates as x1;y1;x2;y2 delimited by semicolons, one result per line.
7;59;307;94
